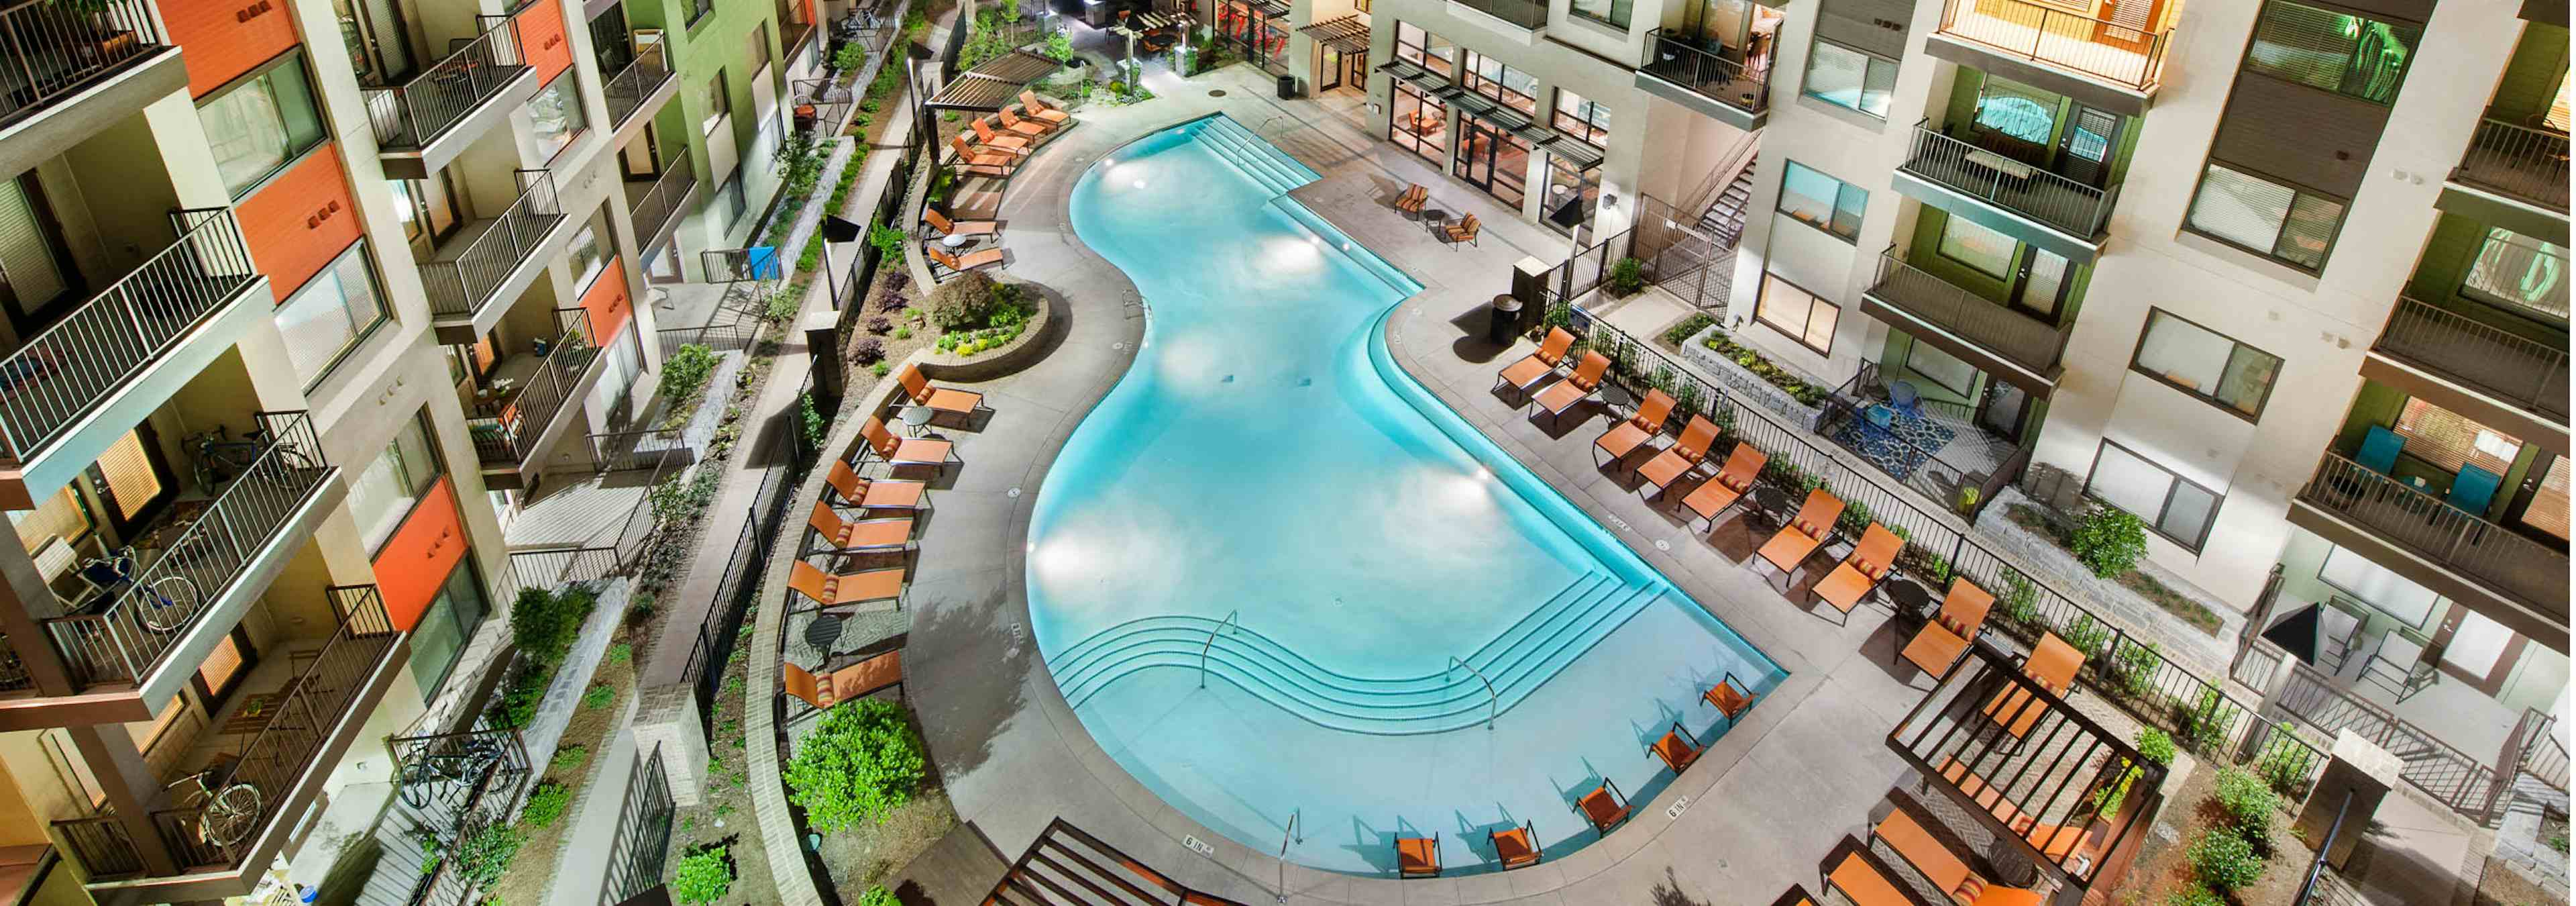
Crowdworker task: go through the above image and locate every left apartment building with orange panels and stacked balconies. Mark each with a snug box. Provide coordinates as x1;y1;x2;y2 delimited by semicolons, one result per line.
0;0;822;903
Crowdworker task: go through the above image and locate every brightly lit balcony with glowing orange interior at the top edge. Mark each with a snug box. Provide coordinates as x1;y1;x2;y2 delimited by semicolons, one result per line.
1924;0;2174;116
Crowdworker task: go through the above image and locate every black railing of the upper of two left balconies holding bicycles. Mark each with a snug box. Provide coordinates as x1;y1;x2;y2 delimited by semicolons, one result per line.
44;412;332;687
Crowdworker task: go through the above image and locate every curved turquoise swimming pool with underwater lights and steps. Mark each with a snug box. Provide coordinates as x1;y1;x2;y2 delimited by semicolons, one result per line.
1028;116;1782;872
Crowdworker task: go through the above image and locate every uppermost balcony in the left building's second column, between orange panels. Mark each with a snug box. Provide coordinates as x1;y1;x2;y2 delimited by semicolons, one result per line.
363;15;539;180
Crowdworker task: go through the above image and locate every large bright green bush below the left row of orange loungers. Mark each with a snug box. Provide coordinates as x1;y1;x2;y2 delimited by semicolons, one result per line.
786;697;948;834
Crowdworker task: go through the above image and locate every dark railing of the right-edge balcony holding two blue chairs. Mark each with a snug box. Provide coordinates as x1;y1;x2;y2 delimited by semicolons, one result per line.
2298;450;2568;615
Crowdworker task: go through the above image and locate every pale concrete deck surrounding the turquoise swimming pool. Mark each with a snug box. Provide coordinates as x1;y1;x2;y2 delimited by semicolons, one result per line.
747;67;1922;903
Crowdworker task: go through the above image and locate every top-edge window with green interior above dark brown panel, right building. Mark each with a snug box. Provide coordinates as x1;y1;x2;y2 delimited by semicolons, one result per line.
2246;0;2424;103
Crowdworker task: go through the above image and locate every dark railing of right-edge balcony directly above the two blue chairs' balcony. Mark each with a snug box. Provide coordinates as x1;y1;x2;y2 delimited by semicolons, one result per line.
2370;296;2568;422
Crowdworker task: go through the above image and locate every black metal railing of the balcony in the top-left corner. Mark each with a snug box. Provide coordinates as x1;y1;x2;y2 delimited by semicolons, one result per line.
0;0;168;123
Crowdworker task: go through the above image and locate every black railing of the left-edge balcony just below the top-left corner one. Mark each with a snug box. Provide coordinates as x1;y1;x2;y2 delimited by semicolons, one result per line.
0;209;260;461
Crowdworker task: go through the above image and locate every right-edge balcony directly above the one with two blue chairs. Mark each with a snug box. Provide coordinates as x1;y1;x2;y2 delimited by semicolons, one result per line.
2362;296;2568;445
